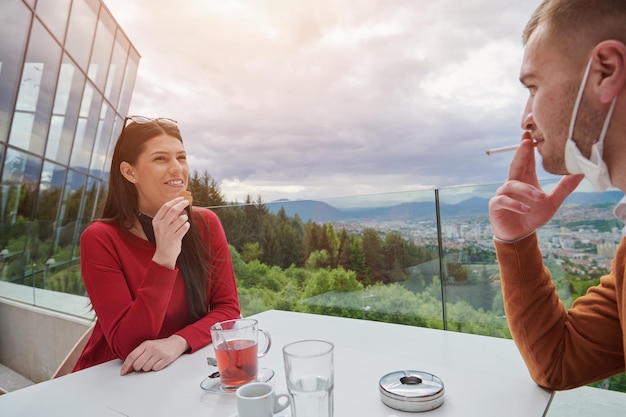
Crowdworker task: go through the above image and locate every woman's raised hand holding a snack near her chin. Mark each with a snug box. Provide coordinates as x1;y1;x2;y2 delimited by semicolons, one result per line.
152;197;189;269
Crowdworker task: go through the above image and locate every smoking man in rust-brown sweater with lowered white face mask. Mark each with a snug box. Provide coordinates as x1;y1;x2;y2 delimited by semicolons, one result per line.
489;0;626;390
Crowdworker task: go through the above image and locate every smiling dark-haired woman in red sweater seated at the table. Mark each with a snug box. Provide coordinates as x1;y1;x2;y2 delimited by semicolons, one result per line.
74;116;240;375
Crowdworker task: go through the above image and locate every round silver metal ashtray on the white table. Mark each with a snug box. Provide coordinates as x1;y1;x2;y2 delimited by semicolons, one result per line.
378;371;444;412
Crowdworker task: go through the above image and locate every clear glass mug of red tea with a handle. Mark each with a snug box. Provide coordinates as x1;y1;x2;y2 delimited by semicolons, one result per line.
211;319;272;390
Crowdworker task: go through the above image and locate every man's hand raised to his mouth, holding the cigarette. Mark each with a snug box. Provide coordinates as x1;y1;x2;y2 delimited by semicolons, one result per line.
489;134;584;241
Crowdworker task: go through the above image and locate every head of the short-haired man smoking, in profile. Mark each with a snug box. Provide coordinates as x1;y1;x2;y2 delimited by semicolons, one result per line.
520;0;626;185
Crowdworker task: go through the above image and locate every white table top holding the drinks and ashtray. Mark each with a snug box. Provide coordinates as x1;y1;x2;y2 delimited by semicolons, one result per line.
0;310;551;417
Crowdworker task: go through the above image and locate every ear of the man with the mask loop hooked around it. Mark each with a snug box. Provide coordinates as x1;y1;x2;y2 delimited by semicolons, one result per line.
592;40;626;103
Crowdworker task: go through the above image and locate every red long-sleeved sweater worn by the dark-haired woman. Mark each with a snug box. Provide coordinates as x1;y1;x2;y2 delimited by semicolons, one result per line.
74;208;240;370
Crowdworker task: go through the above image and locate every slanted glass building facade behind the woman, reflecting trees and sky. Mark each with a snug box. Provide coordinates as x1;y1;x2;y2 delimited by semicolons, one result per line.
0;0;140;294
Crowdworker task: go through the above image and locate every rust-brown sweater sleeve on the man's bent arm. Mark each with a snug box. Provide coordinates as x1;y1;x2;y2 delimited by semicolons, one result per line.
495;234;624;389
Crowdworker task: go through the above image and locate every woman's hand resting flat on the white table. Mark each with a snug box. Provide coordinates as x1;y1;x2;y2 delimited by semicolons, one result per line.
120;334;189;375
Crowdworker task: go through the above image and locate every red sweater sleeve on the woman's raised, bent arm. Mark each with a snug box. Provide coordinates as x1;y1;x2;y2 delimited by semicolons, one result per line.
80;222;178;359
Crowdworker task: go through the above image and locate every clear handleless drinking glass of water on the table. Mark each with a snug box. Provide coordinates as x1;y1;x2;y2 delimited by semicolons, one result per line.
283;340;334;417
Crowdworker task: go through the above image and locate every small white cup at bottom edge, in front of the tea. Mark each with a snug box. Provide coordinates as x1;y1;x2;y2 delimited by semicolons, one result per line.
236;382;291;417
